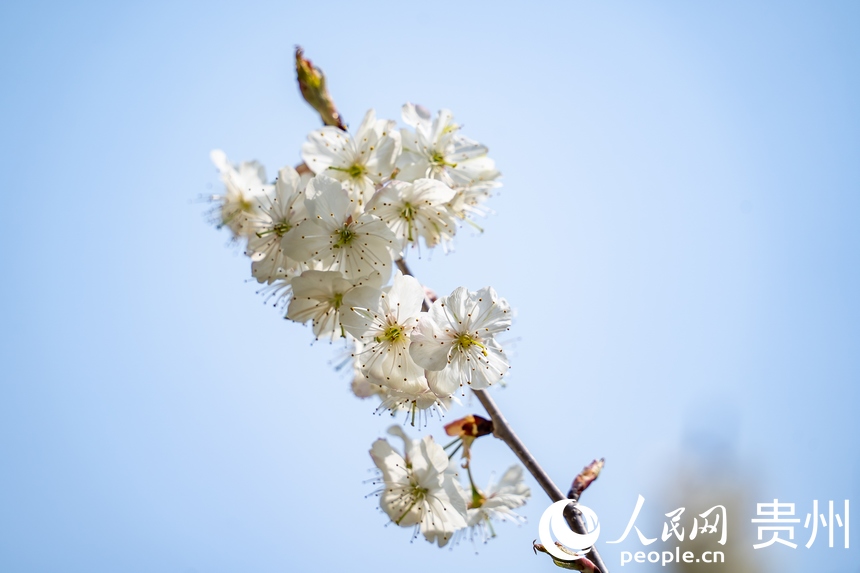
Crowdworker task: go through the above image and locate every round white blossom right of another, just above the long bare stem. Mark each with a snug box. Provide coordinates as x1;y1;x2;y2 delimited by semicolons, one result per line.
409;287;511;393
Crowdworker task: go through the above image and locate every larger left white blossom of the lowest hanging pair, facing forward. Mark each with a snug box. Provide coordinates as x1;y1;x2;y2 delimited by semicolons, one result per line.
370;426;466;547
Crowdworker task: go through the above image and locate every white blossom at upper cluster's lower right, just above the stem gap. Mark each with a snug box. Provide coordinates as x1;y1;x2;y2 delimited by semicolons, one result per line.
367;178;457;249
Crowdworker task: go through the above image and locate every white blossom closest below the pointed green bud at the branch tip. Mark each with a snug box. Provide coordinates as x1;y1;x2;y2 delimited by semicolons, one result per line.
302;109;400;210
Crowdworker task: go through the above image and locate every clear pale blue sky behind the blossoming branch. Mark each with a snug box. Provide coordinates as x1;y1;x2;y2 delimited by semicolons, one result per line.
0;1;860;573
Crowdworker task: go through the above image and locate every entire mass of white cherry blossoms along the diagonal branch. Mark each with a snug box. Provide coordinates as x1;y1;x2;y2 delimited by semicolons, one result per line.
212;104;529;546
